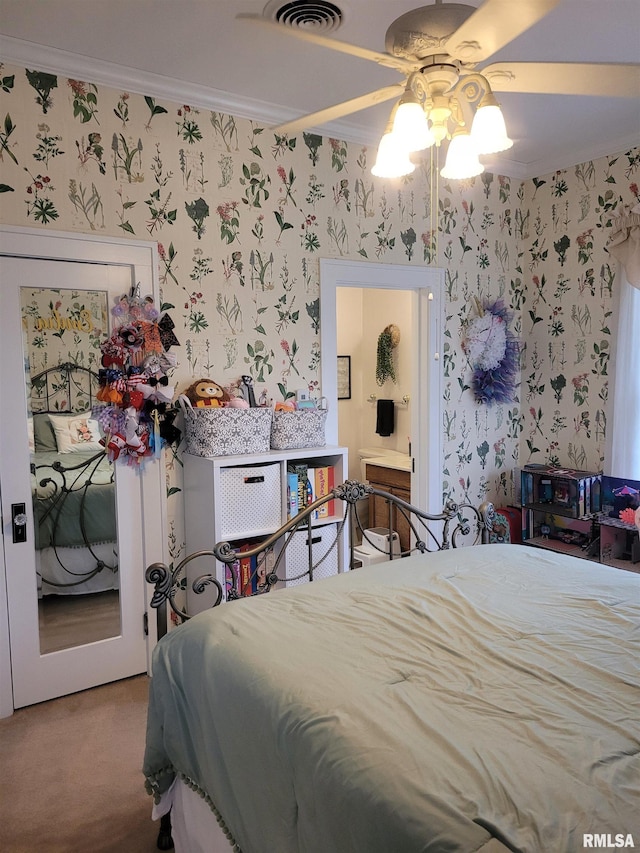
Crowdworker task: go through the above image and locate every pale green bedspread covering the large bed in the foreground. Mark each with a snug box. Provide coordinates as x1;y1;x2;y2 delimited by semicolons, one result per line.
144;545;640;853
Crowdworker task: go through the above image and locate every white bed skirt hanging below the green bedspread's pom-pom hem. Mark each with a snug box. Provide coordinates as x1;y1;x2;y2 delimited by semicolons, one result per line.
152;779;233;853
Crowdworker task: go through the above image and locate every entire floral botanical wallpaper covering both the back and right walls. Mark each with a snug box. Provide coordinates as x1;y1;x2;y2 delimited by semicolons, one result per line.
0;60;640;554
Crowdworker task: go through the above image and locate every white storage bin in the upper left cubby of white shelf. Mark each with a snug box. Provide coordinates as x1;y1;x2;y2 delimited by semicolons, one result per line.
220;462;282;541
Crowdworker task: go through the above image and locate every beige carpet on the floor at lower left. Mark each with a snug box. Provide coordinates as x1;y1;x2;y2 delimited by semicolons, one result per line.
0;676;158;853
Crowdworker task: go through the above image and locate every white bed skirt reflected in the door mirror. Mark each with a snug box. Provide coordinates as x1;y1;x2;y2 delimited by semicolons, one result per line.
36;542;120;598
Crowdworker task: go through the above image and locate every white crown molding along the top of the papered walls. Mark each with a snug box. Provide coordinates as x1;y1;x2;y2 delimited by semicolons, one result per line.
0;35;638;180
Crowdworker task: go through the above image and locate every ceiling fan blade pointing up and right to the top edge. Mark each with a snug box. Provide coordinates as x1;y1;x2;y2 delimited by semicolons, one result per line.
447;0;560;62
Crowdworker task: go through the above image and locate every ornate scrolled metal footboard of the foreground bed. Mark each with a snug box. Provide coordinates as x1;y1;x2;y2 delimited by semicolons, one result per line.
146;480;495;636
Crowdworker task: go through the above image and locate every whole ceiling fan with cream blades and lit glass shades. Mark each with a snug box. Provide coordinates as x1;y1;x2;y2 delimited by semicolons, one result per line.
237;0;640;178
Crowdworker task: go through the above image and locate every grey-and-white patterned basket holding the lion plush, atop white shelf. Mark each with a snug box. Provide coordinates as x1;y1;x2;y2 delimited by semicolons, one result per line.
183;407;273;456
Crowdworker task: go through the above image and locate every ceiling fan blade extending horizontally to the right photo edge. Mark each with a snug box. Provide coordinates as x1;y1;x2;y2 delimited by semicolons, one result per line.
482;62;640;98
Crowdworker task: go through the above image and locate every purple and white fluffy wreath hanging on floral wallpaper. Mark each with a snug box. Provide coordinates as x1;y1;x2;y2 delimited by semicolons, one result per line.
462;297;519;406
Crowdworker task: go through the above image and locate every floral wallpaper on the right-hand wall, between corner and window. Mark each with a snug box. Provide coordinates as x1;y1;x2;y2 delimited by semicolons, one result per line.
513;159;640;471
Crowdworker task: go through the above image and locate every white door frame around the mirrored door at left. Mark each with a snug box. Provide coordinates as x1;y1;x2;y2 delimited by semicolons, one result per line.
0;226;167;717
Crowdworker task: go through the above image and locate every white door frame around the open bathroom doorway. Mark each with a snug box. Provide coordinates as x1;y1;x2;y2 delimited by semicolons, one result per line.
320;258;444;513
